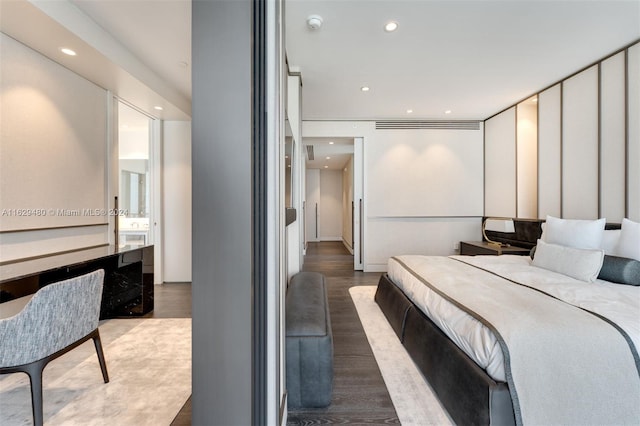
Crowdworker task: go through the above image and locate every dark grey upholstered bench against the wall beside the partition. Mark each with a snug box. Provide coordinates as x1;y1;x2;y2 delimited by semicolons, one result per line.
285;272;333;408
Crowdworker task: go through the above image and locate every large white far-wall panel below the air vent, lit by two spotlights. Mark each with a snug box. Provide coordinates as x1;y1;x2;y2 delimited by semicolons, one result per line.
365;129;482;217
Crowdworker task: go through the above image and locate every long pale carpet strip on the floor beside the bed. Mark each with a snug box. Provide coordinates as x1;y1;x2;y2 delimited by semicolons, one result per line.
349;286;454;426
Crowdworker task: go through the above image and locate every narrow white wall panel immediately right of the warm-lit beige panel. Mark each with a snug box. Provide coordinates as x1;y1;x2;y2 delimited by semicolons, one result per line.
538;84;562;218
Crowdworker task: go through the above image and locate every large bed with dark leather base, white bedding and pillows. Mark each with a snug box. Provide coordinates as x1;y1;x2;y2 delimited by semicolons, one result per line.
375;218;640;425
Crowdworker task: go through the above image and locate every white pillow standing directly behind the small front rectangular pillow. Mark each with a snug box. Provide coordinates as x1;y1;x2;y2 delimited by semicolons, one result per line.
542;216;606;249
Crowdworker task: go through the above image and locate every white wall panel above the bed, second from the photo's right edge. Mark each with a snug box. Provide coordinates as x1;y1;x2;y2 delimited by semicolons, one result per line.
600;52;626;223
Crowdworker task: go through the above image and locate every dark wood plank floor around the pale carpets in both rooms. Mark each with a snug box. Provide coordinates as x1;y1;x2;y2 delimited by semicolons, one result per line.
165;242;400;426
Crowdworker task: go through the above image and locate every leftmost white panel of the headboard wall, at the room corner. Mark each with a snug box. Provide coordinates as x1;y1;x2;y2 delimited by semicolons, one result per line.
484;107;516;217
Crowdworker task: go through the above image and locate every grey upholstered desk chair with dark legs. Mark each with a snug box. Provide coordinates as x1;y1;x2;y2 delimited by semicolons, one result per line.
0;269;109;426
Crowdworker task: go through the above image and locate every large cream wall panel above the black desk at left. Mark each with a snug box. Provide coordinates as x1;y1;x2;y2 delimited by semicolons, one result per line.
0;34;108;231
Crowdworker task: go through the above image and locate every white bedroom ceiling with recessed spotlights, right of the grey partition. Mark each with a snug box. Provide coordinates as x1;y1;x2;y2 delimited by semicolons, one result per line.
286;0;640;120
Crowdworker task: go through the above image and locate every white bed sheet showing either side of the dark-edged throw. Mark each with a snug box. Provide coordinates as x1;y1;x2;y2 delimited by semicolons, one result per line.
387;255;640;382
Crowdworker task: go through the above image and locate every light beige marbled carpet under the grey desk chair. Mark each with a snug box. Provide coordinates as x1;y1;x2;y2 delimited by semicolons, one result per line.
0;318;191;426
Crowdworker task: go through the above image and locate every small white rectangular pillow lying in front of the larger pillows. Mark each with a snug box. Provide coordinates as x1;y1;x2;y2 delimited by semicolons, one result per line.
531;240;604;283
